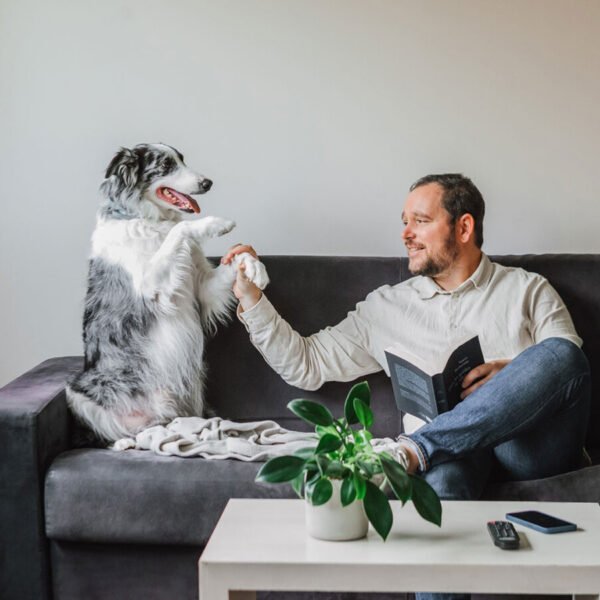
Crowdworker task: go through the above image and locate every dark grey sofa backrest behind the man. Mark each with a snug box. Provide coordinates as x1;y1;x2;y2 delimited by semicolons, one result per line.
206;254;600;447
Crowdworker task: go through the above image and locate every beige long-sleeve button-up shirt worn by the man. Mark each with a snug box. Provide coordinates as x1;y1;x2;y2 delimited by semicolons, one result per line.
238;254;582;431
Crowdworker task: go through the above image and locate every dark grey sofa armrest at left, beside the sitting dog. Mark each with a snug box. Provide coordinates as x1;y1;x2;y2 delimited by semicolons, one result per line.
0;357;83;600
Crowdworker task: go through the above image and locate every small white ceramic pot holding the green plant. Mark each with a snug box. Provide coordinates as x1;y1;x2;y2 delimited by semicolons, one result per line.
305;479;369;542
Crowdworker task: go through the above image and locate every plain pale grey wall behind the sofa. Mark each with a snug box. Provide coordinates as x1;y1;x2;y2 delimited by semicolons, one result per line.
0;0;600;384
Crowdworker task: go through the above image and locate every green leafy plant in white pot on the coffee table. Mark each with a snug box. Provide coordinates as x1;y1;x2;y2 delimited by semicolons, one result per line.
256;382;442;540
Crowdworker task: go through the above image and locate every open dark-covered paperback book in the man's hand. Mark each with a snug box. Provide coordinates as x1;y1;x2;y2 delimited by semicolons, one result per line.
385;336;484;422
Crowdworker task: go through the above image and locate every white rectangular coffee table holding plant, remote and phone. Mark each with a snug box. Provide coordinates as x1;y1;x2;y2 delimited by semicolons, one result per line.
200;499;600;600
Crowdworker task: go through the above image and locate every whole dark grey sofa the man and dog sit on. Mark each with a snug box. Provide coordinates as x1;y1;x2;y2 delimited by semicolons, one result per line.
0;255;600;600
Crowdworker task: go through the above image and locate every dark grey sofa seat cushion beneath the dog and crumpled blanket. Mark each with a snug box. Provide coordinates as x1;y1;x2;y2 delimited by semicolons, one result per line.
45;448;295;546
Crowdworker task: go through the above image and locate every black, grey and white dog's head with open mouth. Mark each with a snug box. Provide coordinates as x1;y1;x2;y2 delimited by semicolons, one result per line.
100;144;212;221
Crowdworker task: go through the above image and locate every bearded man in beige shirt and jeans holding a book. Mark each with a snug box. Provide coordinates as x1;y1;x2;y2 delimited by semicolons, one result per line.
223;174;590;588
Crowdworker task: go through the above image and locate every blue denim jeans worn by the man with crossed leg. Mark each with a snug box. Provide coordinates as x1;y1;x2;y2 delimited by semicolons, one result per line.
399;338;591;600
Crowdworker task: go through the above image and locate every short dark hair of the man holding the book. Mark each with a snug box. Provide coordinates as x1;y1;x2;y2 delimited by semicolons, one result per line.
410;173;485;248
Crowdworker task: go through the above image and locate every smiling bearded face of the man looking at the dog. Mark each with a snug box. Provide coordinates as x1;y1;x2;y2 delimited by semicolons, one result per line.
402;183;458;277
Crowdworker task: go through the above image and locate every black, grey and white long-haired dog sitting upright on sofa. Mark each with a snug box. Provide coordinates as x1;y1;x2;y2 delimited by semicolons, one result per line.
66;144;269;443
